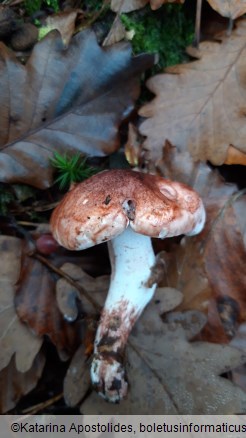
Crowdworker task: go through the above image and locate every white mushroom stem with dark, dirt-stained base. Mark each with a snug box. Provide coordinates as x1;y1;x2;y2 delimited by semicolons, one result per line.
91;227;156;402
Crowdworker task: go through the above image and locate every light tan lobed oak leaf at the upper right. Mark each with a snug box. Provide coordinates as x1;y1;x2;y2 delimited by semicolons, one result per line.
139;20;246;165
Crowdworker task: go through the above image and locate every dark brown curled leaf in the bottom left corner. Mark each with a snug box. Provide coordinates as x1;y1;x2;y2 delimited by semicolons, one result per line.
0;353;45;414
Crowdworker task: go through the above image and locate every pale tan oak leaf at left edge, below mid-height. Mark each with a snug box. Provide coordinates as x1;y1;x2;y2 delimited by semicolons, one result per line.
0;236;42;373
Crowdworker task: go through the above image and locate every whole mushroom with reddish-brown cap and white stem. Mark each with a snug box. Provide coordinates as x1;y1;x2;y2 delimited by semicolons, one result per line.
51;169;205;402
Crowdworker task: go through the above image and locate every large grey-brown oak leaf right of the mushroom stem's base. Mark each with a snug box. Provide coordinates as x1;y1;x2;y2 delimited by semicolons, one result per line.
81;302;246;415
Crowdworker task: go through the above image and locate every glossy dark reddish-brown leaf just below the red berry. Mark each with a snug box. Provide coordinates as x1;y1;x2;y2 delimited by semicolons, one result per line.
15;251;80;360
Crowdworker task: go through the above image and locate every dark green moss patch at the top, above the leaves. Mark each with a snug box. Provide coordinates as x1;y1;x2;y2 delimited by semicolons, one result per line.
121;5;194;70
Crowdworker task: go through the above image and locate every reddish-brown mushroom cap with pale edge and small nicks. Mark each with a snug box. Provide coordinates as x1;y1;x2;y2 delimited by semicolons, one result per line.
51;169;205;250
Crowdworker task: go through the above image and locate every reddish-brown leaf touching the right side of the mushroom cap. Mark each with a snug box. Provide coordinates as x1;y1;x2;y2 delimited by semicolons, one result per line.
158;145;246;342
